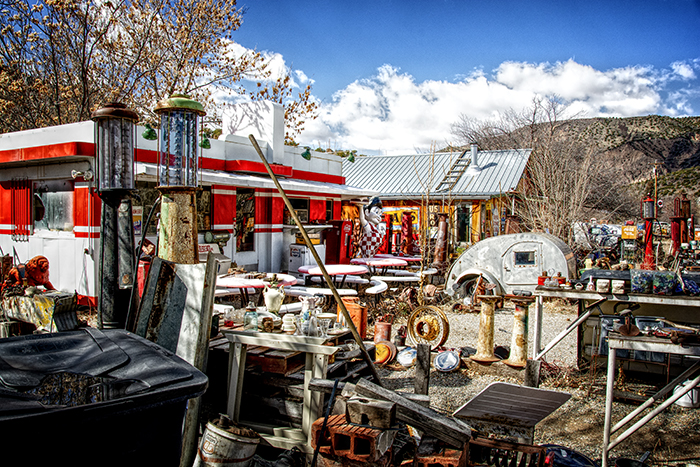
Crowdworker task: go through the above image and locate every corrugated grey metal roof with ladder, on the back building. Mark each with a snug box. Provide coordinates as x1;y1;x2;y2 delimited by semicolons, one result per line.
343;149;532;199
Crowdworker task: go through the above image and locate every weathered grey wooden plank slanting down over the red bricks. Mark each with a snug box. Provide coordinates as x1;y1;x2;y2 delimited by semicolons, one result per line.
355;379;471;449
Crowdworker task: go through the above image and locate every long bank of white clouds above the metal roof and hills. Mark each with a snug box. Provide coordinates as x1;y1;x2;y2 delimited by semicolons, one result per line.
298;60;698;154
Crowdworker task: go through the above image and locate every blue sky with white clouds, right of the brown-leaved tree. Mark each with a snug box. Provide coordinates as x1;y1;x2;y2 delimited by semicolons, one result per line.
227;0;700;154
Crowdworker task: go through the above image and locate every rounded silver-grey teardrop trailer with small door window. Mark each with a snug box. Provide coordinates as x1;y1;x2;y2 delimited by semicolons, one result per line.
445;232;576;299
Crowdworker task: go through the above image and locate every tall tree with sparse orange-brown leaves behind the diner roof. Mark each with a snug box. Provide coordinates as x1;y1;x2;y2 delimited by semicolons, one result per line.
0;0;316;139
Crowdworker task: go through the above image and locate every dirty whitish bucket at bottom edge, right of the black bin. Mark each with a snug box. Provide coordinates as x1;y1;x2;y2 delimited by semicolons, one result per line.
193;419;260;467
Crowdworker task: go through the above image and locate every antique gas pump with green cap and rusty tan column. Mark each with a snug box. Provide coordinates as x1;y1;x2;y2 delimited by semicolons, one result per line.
154;94;206;264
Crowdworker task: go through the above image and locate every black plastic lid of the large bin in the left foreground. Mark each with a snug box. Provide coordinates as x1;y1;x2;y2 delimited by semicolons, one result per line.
0;328;208;418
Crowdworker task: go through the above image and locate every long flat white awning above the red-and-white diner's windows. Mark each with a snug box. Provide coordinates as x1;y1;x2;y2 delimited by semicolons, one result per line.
136;162;379;199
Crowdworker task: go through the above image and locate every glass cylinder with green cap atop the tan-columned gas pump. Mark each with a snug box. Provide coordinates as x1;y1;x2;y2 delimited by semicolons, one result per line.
154;94;205;187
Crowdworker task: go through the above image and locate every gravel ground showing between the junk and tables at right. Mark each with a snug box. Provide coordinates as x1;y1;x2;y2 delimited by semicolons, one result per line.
378;302;700;466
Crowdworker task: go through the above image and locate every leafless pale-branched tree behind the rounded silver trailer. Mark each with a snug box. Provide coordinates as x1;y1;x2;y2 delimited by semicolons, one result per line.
452;97;617;247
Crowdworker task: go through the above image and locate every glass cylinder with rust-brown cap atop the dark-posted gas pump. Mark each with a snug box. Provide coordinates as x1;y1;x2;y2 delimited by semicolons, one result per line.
92;102;139;191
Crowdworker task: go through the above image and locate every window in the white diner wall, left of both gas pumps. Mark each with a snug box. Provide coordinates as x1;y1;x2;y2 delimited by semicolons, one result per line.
32;180;73;232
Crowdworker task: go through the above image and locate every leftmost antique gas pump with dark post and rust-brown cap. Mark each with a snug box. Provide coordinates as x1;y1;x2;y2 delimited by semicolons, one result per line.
92;103;139;328
